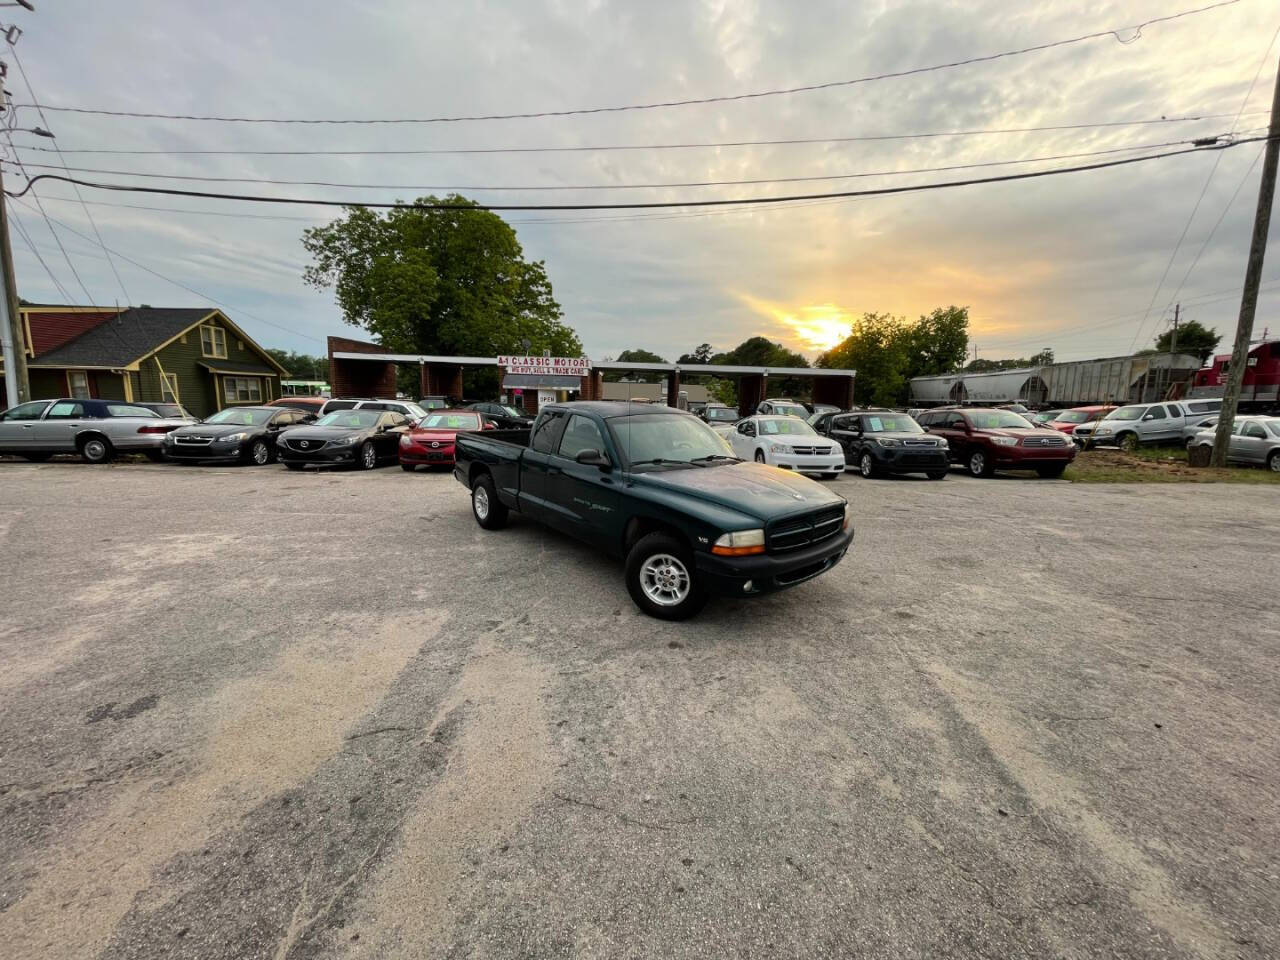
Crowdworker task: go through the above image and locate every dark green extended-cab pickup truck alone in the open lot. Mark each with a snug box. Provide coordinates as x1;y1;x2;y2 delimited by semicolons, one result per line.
453;402;854;620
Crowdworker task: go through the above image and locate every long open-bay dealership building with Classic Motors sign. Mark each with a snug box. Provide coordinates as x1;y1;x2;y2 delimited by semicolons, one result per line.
329;337;855;413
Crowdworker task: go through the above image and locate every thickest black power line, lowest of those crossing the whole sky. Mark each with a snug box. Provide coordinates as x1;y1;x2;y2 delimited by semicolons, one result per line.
6;137;1267;211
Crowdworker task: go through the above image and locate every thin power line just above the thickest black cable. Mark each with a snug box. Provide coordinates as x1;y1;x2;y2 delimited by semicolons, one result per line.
5;137;1233;192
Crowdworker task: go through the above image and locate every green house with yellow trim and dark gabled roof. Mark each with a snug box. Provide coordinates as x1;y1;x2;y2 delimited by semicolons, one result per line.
20;305;288;417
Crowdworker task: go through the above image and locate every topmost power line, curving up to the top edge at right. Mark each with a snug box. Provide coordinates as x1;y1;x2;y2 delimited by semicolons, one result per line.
10;0;1239;125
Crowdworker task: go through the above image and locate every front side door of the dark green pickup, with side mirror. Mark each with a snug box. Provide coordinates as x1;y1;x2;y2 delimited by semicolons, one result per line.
545;413;622;544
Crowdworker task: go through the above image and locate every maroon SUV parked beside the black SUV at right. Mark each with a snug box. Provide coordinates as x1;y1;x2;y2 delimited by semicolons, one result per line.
916;408;1075;477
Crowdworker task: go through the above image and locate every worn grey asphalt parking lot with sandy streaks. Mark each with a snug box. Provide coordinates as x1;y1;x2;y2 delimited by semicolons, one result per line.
0;462;1280;960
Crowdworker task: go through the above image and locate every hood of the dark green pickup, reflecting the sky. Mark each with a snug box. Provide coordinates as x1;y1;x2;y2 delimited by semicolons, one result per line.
631;462;845;522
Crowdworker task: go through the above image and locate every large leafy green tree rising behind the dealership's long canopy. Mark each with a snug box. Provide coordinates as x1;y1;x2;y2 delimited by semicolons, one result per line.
302;195;582;356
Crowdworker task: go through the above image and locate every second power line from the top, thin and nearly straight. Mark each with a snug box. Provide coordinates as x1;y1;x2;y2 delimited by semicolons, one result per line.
10;108;1270;156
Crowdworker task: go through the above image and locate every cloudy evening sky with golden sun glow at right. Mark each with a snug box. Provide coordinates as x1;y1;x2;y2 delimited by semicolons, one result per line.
0;0;1280;358
